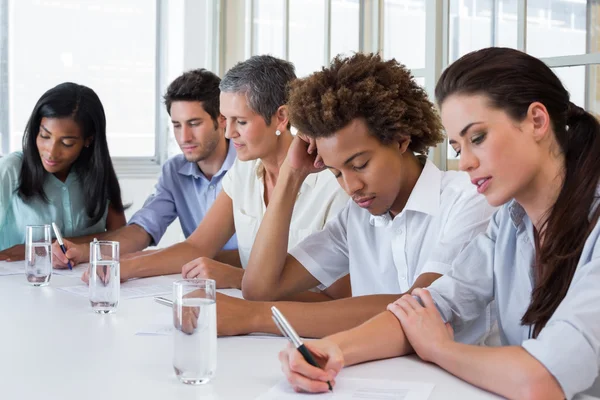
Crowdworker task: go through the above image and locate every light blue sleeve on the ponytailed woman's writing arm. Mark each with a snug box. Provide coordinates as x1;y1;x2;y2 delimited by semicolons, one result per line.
428;208;507;340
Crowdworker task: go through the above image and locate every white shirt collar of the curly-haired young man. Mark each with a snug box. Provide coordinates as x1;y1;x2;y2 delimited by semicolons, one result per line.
370;160;443;226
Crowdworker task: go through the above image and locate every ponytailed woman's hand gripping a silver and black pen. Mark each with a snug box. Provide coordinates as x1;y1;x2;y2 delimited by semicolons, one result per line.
271;307;344;393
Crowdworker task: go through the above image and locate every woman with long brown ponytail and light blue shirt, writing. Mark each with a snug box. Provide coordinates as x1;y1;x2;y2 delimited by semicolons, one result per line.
280;48;600;399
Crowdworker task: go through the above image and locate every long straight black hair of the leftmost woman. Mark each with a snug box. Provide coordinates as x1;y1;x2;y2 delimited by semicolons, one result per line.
18;82;124;225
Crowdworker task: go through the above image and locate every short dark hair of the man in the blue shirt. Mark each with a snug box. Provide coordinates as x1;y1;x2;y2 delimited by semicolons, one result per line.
163;68;221;127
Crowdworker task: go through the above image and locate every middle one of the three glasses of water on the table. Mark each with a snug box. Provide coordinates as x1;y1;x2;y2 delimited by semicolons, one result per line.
89;240;121;314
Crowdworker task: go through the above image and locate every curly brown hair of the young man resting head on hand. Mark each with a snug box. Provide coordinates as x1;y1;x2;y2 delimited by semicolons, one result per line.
288;53;444;154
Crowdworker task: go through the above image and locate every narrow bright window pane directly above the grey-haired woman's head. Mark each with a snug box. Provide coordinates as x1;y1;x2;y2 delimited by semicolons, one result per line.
252;0;285;58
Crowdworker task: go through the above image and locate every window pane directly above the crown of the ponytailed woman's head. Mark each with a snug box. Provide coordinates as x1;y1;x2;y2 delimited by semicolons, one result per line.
449;0;520;62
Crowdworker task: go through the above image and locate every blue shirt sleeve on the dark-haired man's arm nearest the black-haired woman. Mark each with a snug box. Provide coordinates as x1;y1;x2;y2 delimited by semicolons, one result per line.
129;164;177;246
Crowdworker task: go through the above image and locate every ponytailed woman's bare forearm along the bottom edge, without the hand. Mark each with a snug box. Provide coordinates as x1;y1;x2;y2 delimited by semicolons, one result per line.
433;342;564;400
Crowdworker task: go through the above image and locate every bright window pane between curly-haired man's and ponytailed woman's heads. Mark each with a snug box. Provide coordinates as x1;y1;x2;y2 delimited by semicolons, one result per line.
383;0;426;69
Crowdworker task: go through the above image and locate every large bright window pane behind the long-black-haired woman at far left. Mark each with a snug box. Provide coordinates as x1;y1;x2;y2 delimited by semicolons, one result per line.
8;0;157;157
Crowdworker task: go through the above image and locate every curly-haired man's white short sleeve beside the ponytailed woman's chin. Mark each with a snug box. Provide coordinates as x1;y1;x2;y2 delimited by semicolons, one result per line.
415;189;496;279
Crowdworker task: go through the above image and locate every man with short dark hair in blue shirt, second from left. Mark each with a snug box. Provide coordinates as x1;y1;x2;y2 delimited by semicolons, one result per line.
53;69;240;267
